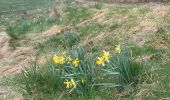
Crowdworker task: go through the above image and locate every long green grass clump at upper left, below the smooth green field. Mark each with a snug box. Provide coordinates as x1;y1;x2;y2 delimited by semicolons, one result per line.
6;17;60;39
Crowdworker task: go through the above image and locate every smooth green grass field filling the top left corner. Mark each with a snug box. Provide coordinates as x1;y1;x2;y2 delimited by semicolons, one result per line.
0;0;54;14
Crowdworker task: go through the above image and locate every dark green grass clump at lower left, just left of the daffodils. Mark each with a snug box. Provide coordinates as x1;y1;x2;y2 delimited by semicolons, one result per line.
18;61;63;98
